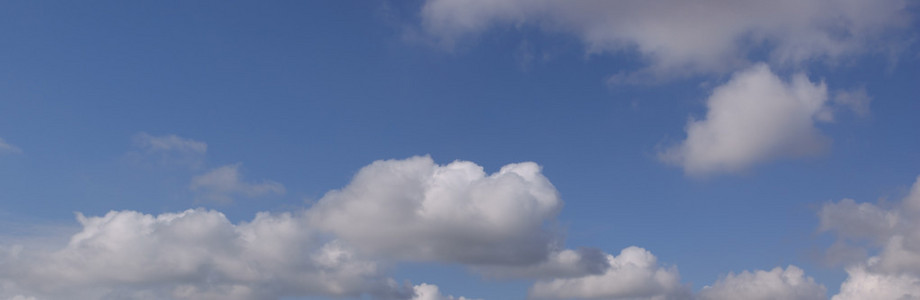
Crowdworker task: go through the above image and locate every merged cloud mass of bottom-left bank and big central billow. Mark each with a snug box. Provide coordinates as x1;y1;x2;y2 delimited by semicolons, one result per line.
0;157;568;299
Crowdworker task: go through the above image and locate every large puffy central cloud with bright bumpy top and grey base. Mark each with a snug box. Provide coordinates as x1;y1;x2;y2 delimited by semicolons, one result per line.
310;156;562;265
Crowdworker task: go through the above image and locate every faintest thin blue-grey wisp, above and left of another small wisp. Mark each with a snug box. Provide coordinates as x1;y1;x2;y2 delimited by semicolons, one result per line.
128;132;208;168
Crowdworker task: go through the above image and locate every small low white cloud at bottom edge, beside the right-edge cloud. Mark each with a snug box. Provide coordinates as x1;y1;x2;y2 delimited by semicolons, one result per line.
699;266;827;300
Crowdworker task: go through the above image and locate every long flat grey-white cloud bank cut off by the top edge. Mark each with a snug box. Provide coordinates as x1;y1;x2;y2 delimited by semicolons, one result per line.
421;0;910;78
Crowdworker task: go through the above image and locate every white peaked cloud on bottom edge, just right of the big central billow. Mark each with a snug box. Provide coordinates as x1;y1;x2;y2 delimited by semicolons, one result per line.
530;247;690;300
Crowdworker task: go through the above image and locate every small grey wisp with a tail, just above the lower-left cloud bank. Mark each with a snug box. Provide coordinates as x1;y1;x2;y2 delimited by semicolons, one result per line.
189;164;285;203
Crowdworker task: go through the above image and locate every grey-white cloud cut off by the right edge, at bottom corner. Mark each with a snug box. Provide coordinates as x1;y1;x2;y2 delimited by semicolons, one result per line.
818;177;920;300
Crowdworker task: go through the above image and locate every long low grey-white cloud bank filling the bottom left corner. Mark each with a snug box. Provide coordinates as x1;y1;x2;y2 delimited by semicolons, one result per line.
0;209;410;299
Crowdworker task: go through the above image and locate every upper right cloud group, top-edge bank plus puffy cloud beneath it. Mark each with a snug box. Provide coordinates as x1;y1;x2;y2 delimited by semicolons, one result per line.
420;0;911;175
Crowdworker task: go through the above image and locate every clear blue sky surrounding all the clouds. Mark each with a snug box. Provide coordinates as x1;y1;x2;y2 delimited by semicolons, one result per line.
0;1;920;299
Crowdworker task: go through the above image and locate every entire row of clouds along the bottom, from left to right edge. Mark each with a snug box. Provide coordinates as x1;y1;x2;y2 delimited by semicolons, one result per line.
0;156;920;300
